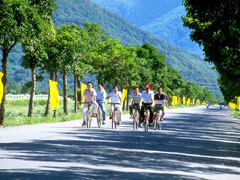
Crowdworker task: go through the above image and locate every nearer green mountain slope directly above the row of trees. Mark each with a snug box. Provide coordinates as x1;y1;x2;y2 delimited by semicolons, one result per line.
53;0;220;95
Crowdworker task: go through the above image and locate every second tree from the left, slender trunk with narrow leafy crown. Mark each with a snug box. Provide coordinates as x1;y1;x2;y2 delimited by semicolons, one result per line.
22;0;56;117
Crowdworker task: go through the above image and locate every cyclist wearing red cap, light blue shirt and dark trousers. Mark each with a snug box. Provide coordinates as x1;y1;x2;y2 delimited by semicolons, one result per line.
140;84;154;126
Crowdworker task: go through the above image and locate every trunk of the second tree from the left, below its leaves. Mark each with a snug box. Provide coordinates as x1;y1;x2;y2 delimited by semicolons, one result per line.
28;66;36;117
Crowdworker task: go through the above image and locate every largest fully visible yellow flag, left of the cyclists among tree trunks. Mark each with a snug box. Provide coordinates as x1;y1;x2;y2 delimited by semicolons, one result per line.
49;80;60;110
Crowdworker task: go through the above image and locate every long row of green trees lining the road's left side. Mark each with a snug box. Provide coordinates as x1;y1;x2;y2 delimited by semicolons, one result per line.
0;0;214;125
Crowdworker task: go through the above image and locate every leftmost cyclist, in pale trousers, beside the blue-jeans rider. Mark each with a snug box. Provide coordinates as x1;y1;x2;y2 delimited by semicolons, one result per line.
82;82;98;126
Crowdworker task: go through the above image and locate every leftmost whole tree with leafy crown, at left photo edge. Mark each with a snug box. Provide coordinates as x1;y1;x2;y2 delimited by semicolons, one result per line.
0;0;44;125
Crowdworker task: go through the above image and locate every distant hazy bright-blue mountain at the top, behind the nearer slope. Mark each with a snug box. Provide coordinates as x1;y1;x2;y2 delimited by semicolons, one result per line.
91;0;202;56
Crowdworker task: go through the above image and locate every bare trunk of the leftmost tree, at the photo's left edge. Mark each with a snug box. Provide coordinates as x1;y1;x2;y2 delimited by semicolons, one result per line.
0;49;9;126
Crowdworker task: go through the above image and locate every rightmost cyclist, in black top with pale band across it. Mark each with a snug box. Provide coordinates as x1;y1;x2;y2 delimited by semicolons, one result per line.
153;87;166;121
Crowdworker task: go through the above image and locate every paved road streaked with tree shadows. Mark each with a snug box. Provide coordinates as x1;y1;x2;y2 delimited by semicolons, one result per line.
0;106;240;180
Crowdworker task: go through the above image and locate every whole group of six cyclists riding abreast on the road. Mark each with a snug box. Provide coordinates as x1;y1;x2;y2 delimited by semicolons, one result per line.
82;82;166;127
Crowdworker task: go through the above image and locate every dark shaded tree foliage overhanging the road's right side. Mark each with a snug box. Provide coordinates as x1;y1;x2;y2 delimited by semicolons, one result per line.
182;0;240;101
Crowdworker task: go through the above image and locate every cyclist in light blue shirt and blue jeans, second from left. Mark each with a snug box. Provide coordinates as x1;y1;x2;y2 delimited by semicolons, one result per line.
96;82;106;124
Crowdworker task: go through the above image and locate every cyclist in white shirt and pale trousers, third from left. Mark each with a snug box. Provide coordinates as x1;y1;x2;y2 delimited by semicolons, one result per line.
108;85;122;125
